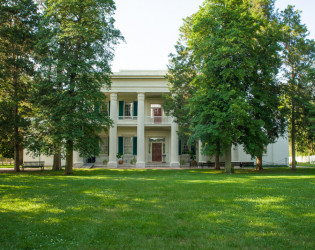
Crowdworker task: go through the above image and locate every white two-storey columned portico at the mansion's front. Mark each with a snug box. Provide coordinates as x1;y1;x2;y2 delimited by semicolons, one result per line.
106;71;180;168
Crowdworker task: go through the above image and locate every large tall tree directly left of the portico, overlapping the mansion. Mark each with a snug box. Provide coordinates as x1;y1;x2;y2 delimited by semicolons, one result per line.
34;0;122;174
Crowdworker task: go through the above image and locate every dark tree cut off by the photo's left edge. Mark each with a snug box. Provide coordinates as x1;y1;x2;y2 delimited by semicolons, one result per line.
0;0;38;171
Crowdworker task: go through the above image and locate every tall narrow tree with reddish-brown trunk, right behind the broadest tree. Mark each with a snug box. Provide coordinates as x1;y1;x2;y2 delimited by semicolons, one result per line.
237;0;287;170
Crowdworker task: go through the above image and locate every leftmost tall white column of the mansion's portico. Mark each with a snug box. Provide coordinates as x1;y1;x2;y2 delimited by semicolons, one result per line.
107;93;117;168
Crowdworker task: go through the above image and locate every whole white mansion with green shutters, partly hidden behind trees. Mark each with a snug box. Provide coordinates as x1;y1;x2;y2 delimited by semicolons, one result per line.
24;71;289;168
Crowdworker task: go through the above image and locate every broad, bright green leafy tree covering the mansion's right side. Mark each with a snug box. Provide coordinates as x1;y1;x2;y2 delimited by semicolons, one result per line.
169;0;285;172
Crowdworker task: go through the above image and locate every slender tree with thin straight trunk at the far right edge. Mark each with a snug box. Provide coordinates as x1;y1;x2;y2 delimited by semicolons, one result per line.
281;5;315;170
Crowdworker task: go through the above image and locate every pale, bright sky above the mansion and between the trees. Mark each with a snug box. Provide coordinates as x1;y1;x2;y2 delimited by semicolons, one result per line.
112;0;315;72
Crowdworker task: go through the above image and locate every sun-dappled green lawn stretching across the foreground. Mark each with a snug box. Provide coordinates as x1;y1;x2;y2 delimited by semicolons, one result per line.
0;168;315;249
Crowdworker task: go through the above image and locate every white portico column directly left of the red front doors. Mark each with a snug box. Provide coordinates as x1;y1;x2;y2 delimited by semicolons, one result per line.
136;93;145;168
